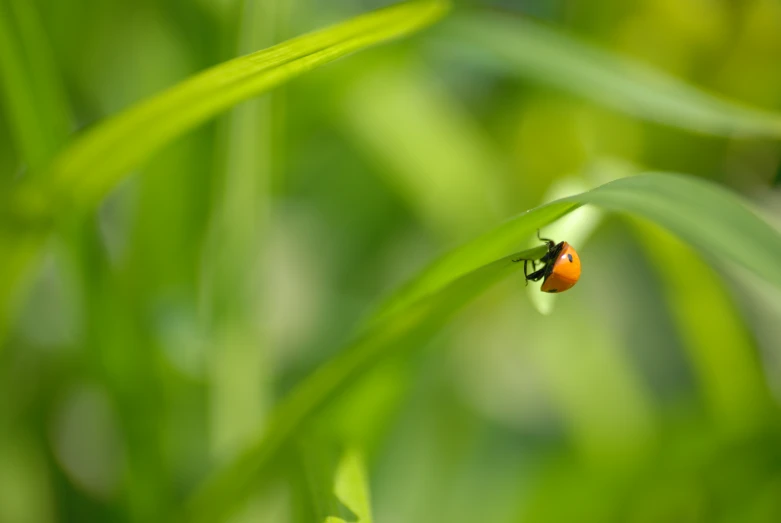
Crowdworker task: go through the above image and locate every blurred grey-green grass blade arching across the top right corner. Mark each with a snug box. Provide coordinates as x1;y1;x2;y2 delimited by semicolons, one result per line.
438;13;781;138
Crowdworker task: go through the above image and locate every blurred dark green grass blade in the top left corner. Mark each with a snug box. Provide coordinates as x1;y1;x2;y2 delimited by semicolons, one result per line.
0;0;70;170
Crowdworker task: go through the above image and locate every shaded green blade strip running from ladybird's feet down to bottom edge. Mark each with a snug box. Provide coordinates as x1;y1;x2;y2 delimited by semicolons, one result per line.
184;252;523;523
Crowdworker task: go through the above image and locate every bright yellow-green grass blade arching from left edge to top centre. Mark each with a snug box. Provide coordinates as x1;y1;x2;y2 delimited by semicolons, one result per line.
0;0;449;348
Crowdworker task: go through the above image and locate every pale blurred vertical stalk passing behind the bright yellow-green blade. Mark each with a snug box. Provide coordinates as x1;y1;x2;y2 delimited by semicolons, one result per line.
202;1;283;459
